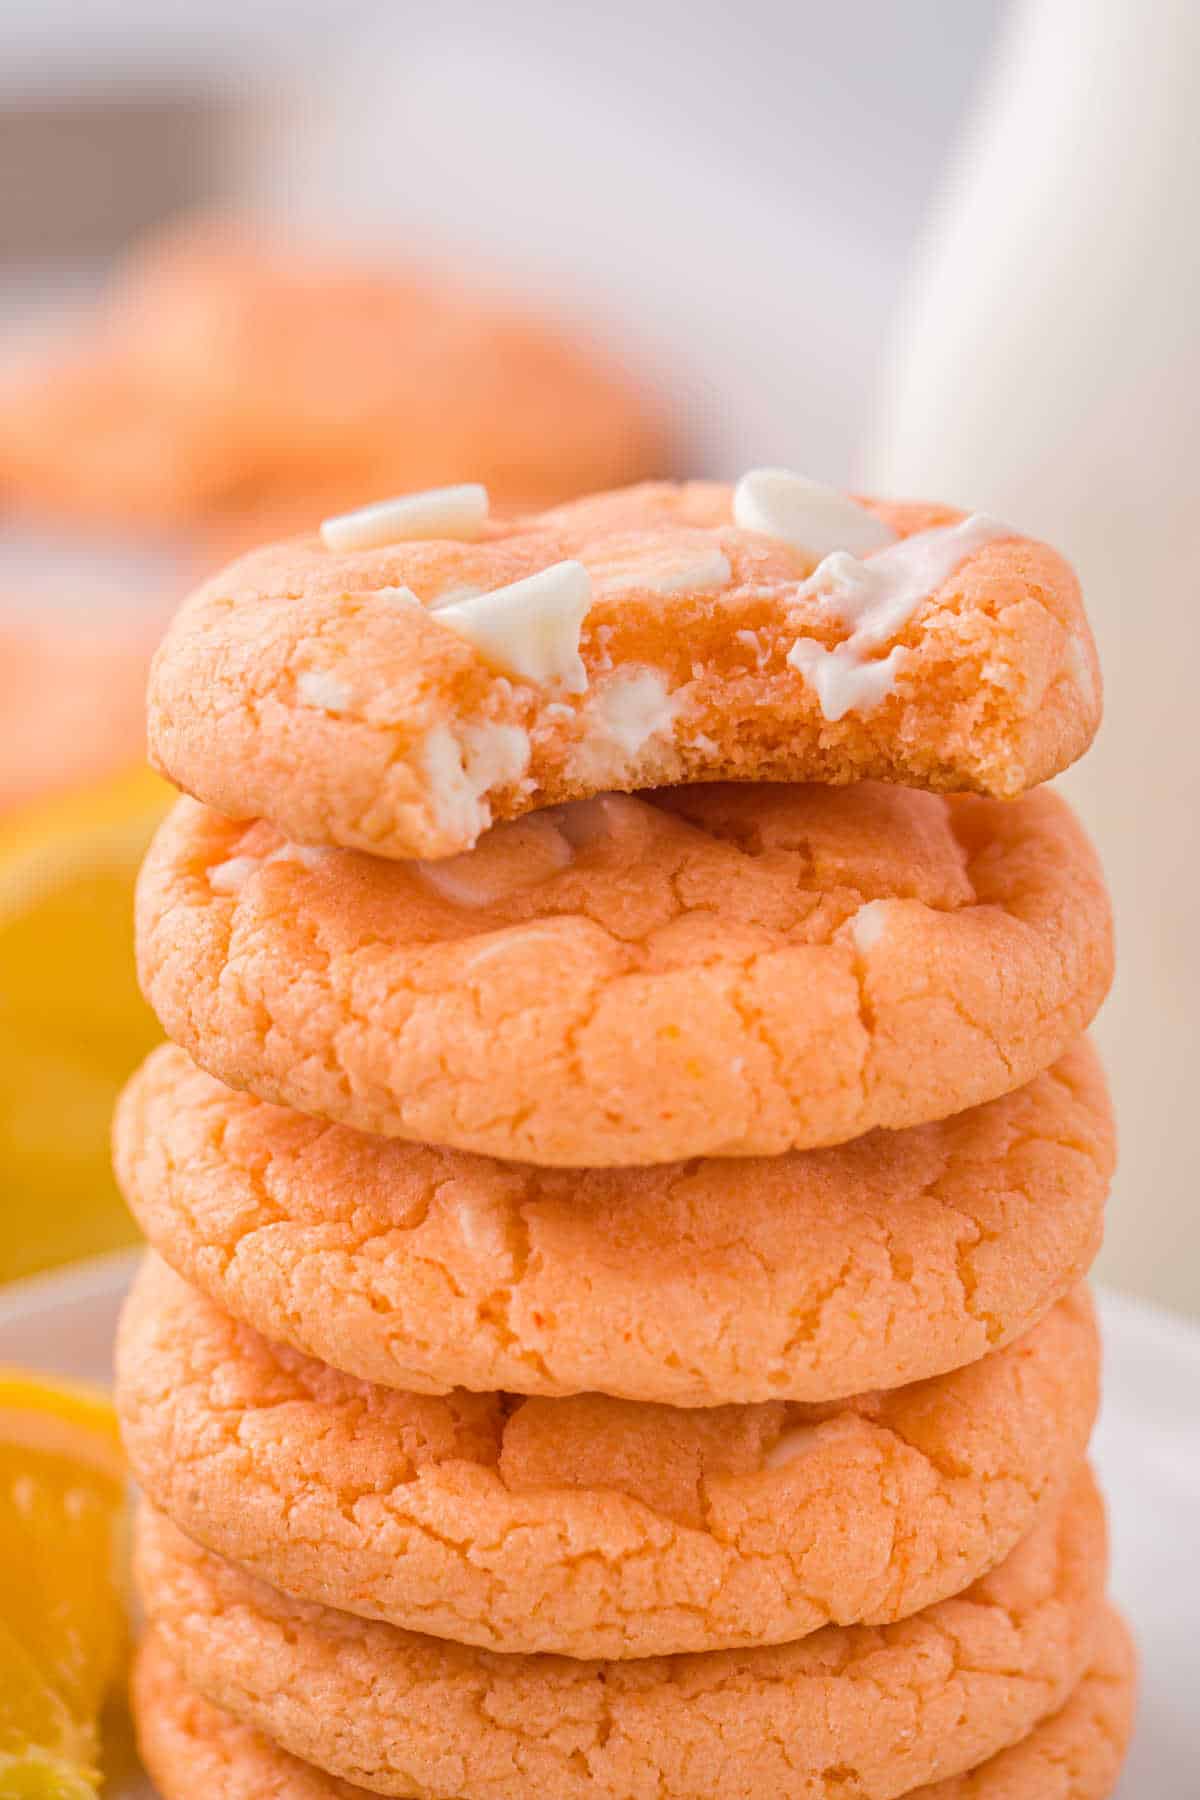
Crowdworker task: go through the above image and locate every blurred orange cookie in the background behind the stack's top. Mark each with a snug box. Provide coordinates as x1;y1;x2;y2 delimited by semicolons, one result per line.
0;218;667;527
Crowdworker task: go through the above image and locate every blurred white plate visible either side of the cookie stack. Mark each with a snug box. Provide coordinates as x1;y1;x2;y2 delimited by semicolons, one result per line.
0;1256;1200;1800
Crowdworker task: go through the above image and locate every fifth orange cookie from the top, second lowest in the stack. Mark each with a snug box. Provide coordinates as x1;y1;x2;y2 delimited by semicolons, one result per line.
131;1472;1106;1800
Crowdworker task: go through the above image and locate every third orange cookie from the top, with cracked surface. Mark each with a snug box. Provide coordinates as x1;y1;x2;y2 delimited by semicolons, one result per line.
115;1042;1114;1406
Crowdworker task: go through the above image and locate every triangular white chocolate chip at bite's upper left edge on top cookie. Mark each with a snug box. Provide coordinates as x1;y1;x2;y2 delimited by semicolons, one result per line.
437;562;592;693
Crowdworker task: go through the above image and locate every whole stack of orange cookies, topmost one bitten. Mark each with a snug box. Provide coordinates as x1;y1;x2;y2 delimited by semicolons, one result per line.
115;470;1133;1800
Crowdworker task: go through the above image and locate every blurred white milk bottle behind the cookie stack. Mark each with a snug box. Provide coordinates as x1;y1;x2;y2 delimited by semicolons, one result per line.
864;0;1200;1310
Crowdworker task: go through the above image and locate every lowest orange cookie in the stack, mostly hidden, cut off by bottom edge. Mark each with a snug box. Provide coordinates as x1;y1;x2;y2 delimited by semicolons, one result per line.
133;1613;1135;1800
